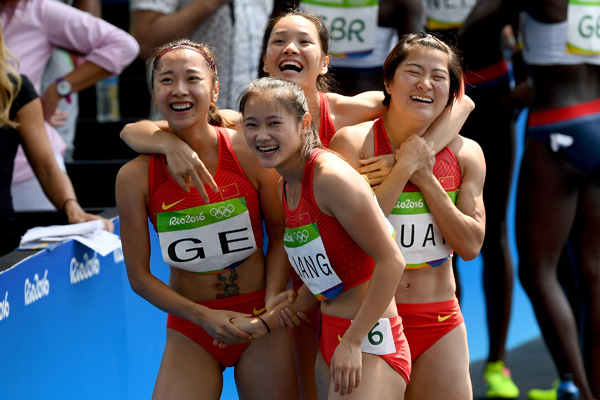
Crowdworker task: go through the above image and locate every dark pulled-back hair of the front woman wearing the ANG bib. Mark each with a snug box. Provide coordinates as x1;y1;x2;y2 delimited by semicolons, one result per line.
239;77;323;159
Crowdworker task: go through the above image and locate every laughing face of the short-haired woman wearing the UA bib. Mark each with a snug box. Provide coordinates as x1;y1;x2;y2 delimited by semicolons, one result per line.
385;47;450;123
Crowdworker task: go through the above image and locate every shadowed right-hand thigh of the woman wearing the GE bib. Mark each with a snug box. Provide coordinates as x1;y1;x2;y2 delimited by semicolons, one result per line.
235;329;298;400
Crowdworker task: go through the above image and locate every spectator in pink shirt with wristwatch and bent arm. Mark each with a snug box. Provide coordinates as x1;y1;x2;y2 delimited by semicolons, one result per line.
0;0;139;210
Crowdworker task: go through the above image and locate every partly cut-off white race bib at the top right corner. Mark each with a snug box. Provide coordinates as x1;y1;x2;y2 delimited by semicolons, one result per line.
567;0;600;55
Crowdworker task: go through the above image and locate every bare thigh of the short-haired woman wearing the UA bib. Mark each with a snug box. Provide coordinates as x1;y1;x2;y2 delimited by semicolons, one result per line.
406;324;473;400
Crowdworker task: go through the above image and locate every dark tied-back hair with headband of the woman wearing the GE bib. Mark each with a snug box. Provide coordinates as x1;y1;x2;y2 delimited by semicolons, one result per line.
146;39;233;128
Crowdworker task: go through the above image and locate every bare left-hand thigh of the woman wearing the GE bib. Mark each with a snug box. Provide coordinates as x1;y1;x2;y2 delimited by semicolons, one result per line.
152;329;223;400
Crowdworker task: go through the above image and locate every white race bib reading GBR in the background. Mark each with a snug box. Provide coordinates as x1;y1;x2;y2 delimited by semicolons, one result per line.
300;0;379;57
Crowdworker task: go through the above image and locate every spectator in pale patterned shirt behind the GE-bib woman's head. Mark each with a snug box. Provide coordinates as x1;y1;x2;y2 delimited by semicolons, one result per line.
130;0;274;112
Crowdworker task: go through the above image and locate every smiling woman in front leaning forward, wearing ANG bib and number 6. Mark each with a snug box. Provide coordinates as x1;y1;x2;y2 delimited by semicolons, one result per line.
240;78;411;399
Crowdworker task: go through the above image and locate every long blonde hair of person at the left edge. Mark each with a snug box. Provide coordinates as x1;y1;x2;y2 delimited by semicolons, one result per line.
0;21;21;128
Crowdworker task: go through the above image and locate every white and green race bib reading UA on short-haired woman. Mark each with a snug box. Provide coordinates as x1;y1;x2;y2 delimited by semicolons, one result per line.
388;192;457;268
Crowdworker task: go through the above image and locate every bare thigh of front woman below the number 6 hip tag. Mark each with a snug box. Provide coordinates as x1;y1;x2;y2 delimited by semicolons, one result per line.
327;353;406;400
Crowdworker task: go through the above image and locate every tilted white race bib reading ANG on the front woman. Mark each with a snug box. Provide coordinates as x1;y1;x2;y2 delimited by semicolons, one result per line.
283;224;344;301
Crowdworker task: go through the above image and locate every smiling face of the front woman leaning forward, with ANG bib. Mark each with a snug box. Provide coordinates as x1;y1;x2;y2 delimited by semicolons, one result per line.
244;95;311;168
